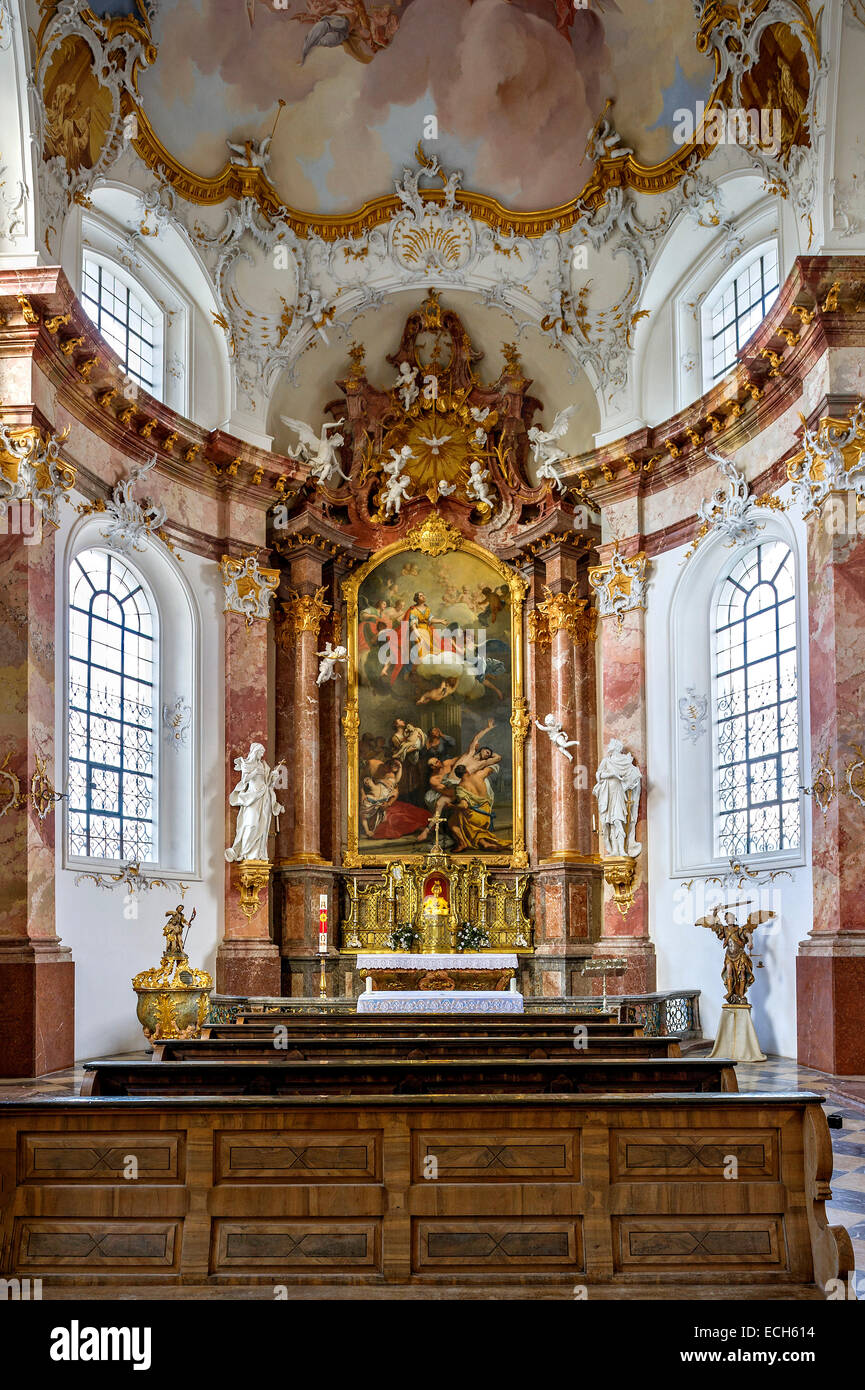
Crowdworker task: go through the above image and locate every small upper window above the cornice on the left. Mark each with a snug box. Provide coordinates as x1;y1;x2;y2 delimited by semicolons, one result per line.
81;256;163;399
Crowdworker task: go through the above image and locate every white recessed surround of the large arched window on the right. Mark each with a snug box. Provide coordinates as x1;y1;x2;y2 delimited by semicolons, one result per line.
669;513;811;878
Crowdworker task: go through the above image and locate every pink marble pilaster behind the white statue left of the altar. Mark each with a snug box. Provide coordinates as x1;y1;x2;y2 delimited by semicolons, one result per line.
217;563;282;995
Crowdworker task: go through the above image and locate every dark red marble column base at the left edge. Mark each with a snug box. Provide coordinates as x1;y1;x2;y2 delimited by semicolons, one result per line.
0;942;75;1077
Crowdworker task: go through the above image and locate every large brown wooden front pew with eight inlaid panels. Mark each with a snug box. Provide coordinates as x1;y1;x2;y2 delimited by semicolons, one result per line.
0;1093;852;1302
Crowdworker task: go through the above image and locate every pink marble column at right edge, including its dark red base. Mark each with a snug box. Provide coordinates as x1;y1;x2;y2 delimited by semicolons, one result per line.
797;517;865;1076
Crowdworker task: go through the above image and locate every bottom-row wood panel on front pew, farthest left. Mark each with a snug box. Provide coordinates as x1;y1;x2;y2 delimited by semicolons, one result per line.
15;1216;181;1270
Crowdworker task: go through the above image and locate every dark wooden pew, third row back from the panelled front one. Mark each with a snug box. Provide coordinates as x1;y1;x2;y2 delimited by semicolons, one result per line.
153;1030;681;1062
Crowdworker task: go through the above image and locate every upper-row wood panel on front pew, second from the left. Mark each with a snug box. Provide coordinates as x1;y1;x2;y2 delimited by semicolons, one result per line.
214;1130;381;1183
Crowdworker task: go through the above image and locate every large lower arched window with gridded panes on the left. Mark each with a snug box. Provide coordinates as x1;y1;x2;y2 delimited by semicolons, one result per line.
67;549;159;863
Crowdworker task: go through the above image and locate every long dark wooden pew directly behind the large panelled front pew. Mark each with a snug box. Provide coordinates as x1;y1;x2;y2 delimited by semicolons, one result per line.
81;1056;737;1097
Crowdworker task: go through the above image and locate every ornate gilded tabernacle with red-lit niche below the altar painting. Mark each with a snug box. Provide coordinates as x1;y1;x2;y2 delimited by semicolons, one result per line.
342;853;533;955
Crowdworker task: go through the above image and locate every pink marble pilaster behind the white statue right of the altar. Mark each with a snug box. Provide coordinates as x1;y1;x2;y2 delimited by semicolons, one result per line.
592;537;656;994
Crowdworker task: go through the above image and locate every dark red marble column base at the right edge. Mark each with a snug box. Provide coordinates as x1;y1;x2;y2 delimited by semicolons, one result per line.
795;933;865;1076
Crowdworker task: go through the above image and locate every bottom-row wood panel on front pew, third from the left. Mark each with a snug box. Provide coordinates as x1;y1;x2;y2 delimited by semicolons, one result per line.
412;1216;583;1273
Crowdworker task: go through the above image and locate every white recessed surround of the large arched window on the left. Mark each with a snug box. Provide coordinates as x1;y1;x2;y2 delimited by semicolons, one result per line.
57;514;202;880
